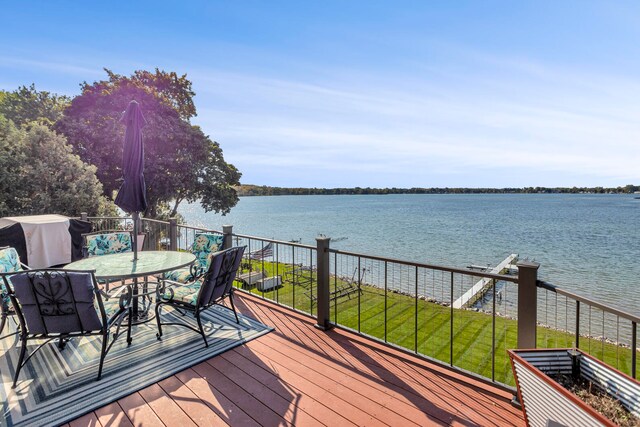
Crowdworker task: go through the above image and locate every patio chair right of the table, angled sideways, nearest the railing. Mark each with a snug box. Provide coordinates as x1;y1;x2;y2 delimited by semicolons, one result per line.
156;246;245;347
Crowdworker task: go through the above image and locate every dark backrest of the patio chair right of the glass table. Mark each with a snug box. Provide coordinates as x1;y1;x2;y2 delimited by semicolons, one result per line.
196;246;246;307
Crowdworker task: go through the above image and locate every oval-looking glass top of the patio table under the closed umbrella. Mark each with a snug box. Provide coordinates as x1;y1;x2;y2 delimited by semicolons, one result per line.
64;251;196;280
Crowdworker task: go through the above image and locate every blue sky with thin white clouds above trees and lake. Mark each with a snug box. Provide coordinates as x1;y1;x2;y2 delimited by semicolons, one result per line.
0;1;640;187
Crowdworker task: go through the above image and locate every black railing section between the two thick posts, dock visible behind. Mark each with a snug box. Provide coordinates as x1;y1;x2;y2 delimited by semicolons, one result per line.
329;246;518;384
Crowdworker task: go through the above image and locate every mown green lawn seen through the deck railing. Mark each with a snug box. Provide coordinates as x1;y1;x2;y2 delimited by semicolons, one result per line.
236;261;632;385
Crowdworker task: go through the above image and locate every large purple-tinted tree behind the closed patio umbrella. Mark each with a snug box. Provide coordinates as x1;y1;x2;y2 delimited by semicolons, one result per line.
55;69;241;218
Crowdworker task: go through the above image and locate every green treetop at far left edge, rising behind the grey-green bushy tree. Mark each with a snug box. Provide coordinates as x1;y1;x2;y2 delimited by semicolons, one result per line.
0;84;70;127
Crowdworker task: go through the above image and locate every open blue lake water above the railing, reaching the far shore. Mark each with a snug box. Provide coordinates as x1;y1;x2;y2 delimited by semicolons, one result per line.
180;194;640;314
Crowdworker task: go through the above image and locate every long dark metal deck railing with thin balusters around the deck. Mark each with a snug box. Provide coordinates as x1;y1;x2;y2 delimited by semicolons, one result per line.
84;218;640;390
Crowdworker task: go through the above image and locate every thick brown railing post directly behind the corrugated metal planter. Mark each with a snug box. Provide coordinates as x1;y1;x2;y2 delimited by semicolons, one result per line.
517;261;540;348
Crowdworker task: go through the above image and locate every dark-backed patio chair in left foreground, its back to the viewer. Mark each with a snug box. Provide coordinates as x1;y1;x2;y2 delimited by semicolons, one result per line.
1;269;132;388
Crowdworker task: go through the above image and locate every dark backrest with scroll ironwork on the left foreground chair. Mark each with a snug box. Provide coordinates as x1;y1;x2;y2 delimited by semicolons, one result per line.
2;269;106;336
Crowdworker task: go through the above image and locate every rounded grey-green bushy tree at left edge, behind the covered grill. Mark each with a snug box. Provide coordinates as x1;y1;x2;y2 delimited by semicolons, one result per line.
0;115;115;216
